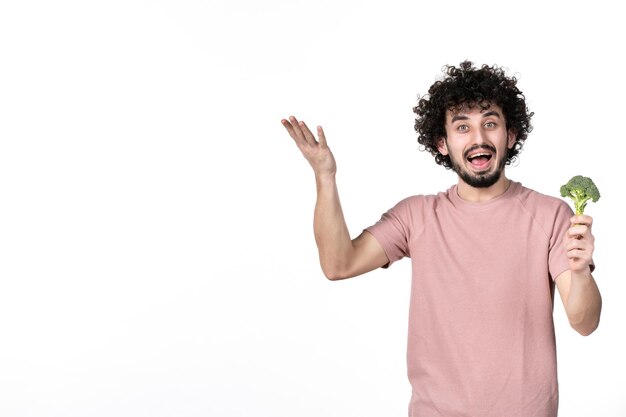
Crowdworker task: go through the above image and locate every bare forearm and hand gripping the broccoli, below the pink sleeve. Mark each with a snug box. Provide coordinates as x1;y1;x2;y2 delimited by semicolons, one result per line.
556;216;602;336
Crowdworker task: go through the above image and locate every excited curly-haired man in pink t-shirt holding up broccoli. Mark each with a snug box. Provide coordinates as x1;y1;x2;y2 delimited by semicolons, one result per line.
282;61;601;417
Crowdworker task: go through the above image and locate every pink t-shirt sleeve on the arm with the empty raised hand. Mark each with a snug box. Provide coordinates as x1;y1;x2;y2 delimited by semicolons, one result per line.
365;197;415;268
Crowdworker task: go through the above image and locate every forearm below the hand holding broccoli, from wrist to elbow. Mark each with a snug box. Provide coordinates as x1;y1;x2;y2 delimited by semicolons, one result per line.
565;270;602;336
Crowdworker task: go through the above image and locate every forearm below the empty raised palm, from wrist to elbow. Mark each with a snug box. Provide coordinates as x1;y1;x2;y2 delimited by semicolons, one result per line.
313;174;354;279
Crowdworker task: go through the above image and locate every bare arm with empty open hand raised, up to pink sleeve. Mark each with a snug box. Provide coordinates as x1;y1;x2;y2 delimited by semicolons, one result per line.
282;116;389;280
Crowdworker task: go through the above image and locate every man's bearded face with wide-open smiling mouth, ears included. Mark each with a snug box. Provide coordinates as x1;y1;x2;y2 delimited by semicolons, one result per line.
438;105;515;188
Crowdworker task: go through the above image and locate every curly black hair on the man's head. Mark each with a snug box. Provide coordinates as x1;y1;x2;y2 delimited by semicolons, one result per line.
413;61;533;169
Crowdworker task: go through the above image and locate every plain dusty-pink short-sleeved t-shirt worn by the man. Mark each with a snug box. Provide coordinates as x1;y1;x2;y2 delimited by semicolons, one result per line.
366;182;573;417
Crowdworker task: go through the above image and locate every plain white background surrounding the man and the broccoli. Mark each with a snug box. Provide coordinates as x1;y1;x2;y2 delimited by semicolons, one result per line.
0;0;626;417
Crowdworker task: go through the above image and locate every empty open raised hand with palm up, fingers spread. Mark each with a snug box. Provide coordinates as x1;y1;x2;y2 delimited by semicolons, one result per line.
281;116;337;176
